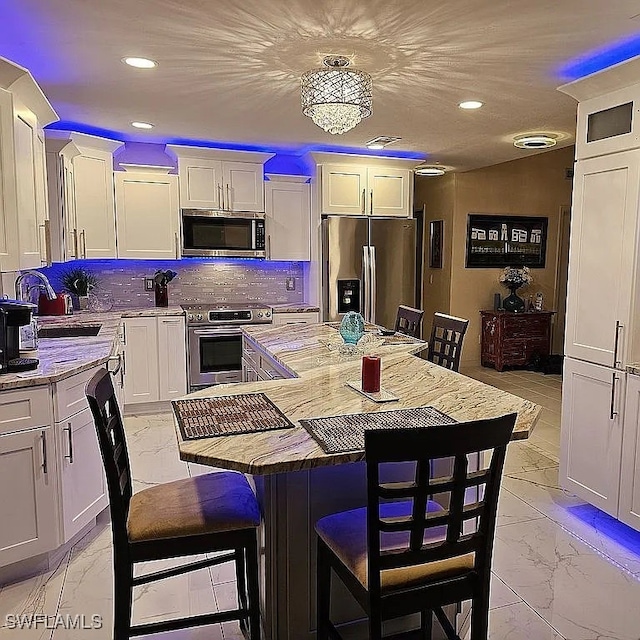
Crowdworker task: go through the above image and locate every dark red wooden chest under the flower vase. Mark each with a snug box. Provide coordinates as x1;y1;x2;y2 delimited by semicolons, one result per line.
480;311;555;371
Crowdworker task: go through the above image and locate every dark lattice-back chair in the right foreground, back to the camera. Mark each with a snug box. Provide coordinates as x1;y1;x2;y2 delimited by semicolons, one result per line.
316;413;516;640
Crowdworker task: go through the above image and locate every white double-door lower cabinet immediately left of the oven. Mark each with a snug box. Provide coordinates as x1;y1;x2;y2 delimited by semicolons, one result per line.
124;316;187;405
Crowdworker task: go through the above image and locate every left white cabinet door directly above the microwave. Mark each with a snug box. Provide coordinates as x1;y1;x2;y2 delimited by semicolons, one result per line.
178;158;223;209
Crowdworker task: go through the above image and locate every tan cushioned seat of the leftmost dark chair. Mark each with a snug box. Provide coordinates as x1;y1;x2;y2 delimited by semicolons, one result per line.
127;472;260;542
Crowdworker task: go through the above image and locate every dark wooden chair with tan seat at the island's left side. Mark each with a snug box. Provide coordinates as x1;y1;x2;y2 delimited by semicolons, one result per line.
86;369;260;640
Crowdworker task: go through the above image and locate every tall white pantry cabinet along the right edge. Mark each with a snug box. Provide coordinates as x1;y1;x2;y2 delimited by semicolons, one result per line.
560;60;640;530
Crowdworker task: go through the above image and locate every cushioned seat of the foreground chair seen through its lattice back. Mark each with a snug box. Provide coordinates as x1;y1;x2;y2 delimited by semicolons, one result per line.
316;500;474;594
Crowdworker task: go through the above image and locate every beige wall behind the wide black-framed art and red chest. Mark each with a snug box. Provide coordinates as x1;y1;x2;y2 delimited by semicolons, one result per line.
416;147;574;364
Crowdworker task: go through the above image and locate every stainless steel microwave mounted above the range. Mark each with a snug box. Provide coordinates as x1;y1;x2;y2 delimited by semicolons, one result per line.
182;209;266;258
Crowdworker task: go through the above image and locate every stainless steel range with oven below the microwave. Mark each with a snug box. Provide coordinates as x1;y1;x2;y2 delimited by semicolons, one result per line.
183;305;272;392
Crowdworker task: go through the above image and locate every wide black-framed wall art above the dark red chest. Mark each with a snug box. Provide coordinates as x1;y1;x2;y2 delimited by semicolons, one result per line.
466;213;549;268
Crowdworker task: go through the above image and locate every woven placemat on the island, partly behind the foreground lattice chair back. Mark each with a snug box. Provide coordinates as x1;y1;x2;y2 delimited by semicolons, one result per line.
300;407;457;453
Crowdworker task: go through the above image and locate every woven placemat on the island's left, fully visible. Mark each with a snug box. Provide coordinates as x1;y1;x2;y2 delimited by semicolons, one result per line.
171;393;294;440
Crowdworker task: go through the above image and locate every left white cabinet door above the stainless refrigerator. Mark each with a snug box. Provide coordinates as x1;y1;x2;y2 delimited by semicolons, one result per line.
322;164;367;215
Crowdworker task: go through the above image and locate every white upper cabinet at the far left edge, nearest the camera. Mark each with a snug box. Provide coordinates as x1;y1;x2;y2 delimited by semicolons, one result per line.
0;58;58;271
